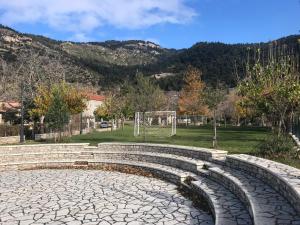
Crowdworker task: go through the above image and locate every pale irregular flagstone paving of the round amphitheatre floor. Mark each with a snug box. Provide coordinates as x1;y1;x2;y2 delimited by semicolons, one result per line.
0;170;213;225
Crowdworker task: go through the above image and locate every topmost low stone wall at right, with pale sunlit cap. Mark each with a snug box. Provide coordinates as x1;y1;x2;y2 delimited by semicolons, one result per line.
226;154;300;213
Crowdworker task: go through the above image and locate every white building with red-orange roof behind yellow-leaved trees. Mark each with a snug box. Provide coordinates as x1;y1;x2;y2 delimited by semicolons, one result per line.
82;94;105;128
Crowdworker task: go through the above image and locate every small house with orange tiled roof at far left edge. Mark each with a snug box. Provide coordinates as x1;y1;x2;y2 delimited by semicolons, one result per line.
0;101;21;124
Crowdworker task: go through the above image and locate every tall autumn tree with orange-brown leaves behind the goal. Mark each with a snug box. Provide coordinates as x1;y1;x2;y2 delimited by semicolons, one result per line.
178;66;208;115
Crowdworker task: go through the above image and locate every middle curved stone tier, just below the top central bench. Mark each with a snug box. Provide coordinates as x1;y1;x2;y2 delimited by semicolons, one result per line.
82;151;204;173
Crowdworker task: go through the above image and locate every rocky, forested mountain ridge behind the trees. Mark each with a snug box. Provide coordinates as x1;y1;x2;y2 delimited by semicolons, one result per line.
0;25;300;97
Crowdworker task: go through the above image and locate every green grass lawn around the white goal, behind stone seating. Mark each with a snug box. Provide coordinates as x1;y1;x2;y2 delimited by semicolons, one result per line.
69;126;270;153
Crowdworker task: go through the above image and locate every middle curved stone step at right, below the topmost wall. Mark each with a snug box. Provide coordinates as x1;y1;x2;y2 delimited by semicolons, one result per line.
209;167;300;225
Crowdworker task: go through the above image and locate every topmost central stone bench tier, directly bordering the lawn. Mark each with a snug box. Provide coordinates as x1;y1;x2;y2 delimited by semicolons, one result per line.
98;143;227;161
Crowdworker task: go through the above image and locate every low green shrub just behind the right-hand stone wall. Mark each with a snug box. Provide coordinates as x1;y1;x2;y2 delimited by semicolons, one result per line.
257;134;294;156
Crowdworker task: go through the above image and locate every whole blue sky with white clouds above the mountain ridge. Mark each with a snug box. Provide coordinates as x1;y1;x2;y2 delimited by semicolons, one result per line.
0;0;300;49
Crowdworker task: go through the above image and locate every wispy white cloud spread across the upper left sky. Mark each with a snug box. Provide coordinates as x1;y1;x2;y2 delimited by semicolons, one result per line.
0;0;196;35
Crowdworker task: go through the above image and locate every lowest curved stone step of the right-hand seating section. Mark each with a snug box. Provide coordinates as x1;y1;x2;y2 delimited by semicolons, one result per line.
191;177;252;225
